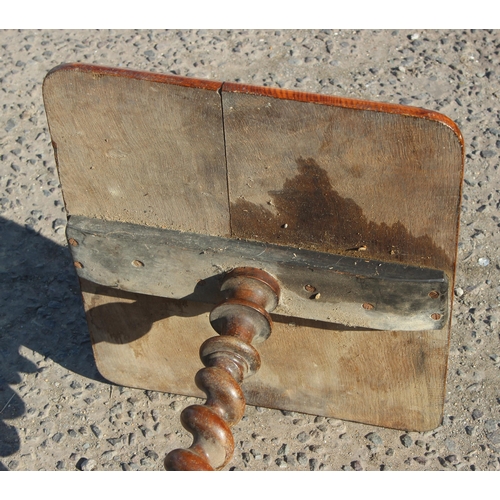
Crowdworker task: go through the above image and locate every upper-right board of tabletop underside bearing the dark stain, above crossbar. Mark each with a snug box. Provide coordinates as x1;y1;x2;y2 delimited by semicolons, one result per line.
223;86;462;273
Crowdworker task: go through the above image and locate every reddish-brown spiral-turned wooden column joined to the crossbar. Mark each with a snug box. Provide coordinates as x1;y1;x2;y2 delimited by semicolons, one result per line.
165;267;280;471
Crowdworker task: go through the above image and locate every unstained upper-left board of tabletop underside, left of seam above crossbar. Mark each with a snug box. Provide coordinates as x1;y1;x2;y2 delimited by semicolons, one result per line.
44;65;229;236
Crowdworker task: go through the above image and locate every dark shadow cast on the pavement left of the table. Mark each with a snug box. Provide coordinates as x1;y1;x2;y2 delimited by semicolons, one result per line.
0;217;103;470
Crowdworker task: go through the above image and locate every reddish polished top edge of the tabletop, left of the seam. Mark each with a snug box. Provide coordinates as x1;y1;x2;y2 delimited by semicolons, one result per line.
45;63;222;91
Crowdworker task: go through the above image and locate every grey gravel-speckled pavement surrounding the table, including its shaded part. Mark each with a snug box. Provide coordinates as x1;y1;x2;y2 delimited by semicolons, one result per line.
0;30;500;471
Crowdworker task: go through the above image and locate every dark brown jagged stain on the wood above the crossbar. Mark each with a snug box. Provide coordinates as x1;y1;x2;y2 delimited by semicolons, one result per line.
231;158;452;270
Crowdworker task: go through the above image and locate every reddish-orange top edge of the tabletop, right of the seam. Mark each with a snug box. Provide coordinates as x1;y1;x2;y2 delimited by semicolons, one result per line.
222;82;464;146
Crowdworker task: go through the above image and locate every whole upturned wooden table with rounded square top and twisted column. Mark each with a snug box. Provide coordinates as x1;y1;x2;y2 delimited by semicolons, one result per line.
44;64;464;468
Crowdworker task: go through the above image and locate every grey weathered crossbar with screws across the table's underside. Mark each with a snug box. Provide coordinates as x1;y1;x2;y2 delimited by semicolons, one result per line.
67;216;449;331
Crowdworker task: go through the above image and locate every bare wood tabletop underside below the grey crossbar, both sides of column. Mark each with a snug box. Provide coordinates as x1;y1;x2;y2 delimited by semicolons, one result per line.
82;281;448;431
